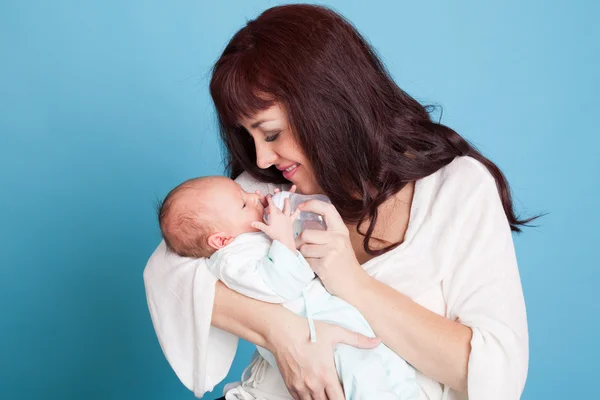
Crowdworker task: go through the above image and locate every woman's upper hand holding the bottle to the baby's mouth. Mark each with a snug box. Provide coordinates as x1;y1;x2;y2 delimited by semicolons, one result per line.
296;200;370;299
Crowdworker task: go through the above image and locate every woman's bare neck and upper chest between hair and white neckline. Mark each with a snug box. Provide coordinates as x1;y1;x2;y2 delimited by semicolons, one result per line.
347;182;415;264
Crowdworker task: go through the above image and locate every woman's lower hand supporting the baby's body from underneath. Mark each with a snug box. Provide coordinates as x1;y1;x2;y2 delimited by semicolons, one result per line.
267;313;380;400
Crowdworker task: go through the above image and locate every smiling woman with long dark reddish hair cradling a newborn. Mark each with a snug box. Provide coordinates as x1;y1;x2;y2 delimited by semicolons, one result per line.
145;5;528;400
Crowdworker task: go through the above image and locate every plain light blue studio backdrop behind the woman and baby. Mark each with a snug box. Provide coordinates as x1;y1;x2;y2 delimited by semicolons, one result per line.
0;0;600;400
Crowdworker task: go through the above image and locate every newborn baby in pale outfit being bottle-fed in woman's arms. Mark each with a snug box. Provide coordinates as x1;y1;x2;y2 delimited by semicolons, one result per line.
159;176;419;400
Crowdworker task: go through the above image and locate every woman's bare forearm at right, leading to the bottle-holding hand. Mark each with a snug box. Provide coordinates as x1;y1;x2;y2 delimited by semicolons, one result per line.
344;277;472;392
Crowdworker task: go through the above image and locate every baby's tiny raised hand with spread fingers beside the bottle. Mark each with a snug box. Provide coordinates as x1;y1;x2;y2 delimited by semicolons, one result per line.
252;196;300;253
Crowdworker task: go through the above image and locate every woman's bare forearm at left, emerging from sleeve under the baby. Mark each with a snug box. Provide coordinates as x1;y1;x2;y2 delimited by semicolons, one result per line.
212;281;291;348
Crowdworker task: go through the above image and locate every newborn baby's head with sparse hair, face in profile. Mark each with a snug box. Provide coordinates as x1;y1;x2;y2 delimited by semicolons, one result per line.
158;176;263;258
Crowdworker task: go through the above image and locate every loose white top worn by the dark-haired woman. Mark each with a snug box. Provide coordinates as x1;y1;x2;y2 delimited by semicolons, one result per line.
144;157;529;400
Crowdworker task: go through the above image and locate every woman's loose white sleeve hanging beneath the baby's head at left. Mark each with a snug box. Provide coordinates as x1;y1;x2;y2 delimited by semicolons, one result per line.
144;173;288;397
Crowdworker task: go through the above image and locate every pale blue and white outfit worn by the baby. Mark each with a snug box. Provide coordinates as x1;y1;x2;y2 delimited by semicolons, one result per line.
208;233;419;400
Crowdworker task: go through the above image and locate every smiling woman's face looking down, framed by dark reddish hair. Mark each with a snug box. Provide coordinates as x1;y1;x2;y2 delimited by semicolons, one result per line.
241;104;323;194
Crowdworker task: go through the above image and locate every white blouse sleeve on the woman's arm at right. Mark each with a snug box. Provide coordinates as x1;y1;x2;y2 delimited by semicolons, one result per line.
444;172;529;400
